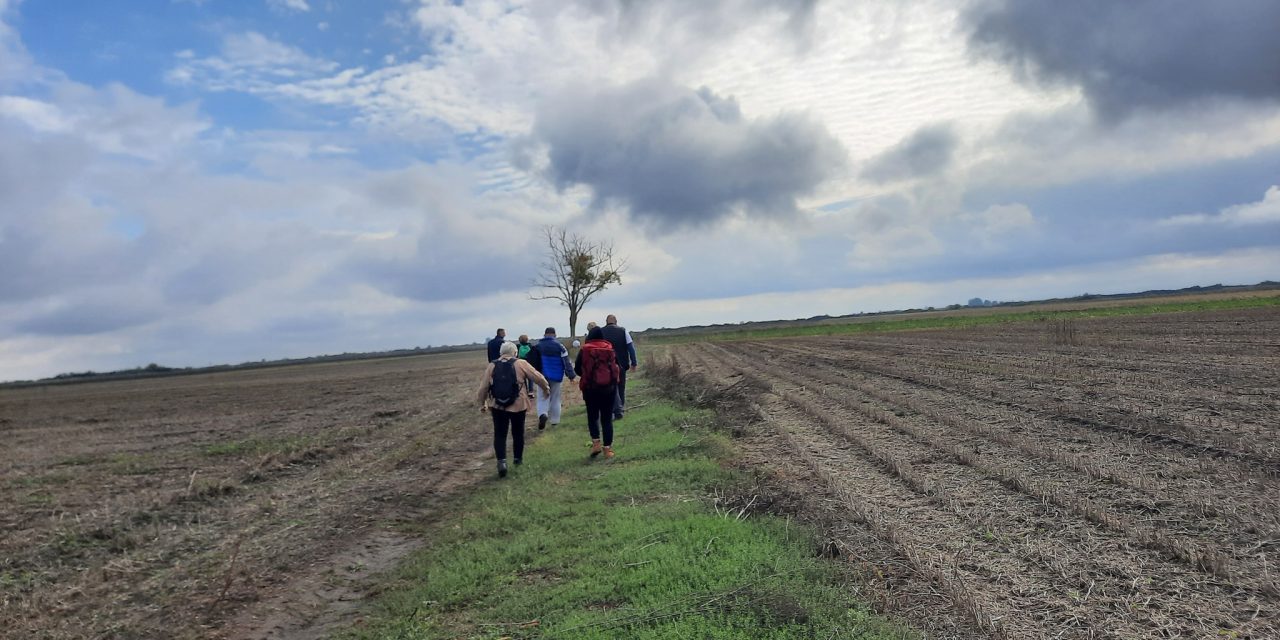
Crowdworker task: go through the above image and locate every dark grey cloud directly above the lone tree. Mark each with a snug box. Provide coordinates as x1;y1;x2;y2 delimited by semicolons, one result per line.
534;81;846;230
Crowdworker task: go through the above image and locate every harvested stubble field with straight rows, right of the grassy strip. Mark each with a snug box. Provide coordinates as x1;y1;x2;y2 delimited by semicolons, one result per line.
668;308;1280;639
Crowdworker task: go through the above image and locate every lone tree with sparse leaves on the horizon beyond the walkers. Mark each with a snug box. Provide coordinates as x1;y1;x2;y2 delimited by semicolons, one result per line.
530;227;627;338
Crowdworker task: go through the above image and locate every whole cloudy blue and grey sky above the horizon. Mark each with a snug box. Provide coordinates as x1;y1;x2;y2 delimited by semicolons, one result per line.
0;0;1280;380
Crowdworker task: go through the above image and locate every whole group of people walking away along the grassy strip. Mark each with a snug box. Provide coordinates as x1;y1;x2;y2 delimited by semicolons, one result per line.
477;314;640;477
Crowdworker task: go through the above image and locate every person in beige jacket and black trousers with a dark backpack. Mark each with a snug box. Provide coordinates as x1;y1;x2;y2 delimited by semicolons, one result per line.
476;342;548;477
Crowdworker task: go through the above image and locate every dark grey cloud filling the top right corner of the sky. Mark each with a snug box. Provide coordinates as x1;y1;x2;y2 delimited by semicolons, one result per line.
966;0;1280;119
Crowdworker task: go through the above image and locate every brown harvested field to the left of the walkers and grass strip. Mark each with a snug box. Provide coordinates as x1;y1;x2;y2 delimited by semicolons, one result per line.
0;353;519;639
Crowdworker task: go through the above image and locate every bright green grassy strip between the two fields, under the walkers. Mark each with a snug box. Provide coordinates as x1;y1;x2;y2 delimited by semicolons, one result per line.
349;380;915;639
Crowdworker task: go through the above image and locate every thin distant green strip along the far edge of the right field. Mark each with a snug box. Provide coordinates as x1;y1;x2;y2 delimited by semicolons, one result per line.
645;296;1280;344
